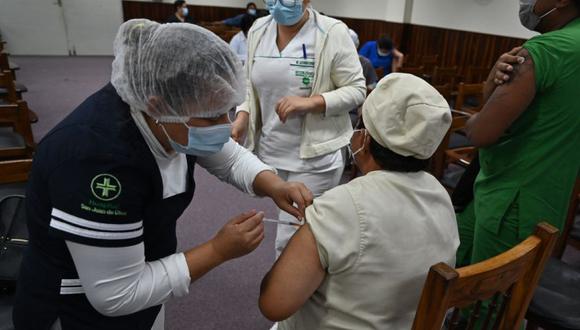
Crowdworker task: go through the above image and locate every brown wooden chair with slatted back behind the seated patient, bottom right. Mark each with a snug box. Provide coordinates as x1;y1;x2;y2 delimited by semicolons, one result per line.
413;223;558;330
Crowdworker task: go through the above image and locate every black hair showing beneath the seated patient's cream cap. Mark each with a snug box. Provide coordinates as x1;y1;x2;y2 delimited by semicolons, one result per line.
357;116;429;173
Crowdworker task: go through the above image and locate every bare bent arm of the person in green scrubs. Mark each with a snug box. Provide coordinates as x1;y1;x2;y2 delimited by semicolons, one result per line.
467;49;536;147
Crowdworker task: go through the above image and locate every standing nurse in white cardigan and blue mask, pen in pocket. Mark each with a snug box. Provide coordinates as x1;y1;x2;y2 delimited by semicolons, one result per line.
232;0;366;255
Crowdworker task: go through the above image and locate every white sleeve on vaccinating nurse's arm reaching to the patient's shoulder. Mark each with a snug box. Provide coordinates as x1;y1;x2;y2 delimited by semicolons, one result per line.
197;139;277;196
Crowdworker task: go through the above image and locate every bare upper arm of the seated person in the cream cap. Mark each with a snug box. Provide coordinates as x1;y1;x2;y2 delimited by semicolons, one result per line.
260;224;326;322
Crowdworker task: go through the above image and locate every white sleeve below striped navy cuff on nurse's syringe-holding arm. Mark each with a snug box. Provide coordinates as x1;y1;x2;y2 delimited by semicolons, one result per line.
66;241;191;316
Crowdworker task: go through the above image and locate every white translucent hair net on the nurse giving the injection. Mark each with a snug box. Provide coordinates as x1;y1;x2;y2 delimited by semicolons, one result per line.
111;19;246;122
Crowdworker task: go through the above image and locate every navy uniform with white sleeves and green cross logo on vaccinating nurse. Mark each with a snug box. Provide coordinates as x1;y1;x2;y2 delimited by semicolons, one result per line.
14;84;271;330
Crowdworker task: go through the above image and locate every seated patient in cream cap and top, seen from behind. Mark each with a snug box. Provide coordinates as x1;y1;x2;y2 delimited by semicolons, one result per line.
260;73;459;330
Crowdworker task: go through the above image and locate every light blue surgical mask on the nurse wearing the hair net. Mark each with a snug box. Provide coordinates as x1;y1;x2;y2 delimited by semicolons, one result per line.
161;124;232;157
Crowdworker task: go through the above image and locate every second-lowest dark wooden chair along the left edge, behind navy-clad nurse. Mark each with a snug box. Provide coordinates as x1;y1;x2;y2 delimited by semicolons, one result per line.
0;101;35;160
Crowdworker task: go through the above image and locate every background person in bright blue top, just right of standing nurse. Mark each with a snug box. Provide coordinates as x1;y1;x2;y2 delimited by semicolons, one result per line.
359;36;404;76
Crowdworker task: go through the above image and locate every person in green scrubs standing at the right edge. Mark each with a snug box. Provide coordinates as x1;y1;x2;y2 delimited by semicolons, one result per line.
458;0;580;324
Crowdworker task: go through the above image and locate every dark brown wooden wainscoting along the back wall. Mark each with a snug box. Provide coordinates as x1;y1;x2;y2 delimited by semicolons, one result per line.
123;1;525;77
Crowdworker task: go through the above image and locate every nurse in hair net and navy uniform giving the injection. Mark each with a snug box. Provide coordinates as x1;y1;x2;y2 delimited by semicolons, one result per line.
14;20;311;330
